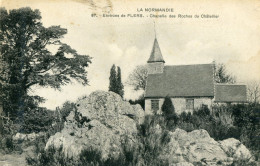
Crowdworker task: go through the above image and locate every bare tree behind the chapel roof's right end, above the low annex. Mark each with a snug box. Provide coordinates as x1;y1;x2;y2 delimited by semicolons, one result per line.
214;63;236;84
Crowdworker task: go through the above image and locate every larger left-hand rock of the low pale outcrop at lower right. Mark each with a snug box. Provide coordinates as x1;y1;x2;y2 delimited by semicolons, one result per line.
163;128;227;163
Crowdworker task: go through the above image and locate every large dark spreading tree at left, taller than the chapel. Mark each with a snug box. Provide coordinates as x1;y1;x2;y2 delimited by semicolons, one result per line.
0;7;91;117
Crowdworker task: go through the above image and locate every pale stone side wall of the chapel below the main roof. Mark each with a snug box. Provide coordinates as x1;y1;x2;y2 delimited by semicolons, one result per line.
145;97;212;114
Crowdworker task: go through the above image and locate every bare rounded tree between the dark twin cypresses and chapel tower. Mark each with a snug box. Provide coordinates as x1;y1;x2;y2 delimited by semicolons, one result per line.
126;65;148;91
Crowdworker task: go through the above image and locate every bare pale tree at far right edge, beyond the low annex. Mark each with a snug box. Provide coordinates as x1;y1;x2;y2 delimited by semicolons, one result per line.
247;81;260;104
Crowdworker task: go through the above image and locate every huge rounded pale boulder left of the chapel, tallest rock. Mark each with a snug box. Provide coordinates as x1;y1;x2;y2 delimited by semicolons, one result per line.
45;91;144;159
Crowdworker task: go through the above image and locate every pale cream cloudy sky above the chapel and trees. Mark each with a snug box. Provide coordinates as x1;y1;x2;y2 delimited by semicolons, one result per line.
0;0;260;109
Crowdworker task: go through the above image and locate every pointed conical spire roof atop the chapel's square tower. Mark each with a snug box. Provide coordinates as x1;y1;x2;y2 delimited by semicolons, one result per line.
147;36;165;63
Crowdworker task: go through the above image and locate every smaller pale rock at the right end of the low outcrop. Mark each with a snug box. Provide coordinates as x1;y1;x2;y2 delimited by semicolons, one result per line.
219;138;251;159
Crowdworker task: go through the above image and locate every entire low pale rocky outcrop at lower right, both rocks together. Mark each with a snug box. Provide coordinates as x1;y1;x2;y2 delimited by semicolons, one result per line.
162;128;251;165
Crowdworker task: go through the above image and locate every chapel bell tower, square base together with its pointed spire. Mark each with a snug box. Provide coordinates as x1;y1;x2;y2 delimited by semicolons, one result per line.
147;37;165;74
